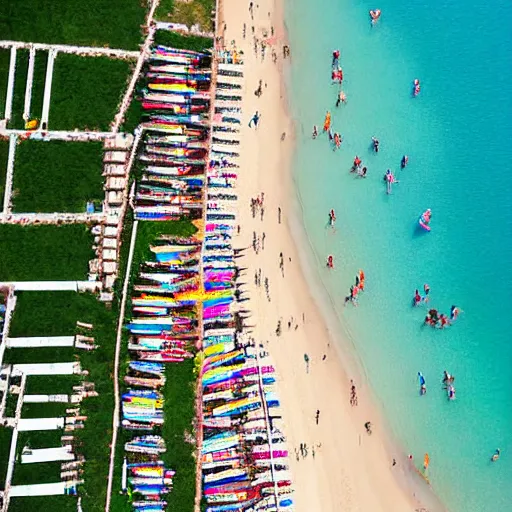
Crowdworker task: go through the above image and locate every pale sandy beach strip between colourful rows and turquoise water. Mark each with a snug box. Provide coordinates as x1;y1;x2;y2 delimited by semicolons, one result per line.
215;0;433;512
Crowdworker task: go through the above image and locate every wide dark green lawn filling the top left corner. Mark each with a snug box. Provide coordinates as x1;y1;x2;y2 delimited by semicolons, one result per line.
0;0;147;50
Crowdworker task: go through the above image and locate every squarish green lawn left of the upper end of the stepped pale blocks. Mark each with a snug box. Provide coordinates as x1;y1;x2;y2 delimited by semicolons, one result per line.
13;140;104;213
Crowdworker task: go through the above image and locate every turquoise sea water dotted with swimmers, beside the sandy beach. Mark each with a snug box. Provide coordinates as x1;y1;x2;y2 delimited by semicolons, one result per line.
286;0;512;512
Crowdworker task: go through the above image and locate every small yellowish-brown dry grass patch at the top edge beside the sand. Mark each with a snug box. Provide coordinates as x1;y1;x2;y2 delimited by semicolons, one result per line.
155;0;215;32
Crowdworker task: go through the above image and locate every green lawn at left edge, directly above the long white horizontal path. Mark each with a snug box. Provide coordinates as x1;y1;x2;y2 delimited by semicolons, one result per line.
0;224;94;281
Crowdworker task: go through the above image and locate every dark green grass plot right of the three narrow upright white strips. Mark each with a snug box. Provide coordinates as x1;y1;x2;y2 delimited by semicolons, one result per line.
48;54;133;131
